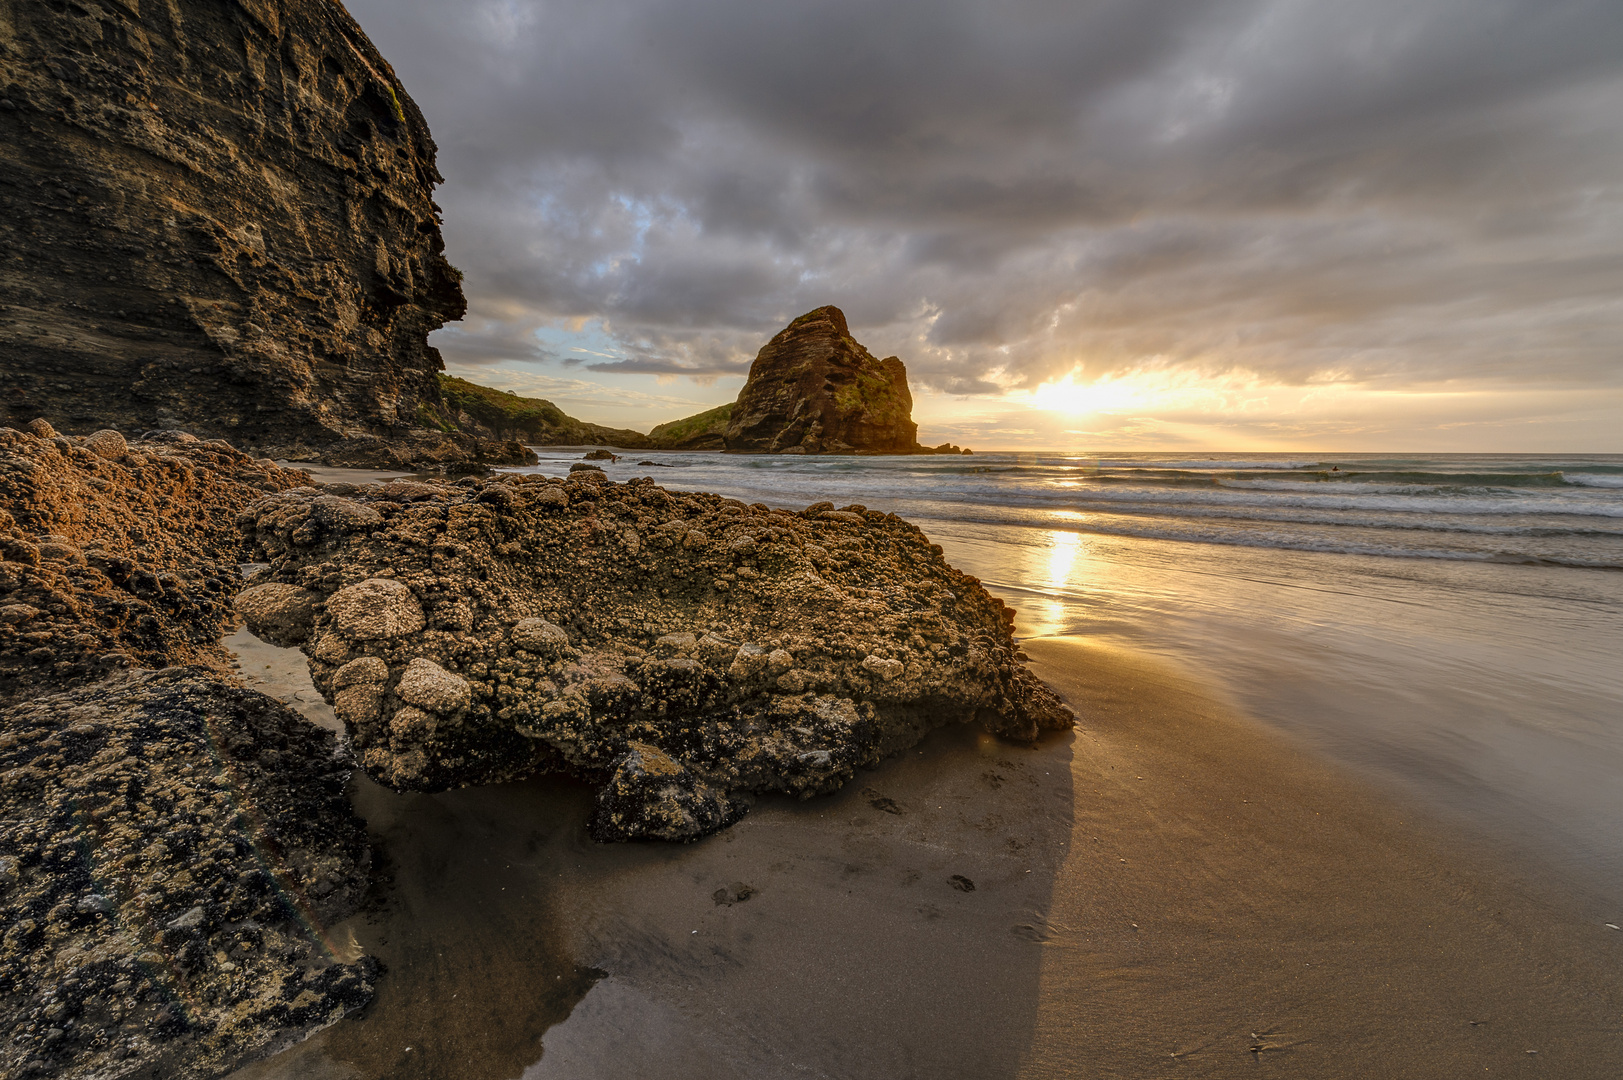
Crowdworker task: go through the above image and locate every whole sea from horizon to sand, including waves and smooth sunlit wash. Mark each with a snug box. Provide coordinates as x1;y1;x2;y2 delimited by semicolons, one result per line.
516;448;1623;911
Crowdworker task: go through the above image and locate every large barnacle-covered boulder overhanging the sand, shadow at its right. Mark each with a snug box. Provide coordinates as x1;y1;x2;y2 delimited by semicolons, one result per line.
237;469;1071;840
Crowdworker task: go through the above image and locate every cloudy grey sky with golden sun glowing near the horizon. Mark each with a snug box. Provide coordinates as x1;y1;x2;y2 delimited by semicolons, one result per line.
347;0;1623;453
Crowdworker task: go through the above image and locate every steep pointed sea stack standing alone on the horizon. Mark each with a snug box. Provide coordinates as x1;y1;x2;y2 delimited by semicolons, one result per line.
727;307;920;453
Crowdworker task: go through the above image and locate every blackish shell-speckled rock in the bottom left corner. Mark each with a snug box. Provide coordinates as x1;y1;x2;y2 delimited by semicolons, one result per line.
0;667;377;1078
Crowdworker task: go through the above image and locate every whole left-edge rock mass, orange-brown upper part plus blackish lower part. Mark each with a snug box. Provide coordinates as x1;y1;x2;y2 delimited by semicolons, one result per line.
0;421;377;1078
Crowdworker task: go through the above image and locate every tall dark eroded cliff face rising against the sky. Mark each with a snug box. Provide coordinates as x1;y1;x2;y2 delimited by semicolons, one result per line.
0;0;464;456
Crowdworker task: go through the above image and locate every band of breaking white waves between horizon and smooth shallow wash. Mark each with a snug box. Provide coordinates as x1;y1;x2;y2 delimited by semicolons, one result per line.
519;448;1623;570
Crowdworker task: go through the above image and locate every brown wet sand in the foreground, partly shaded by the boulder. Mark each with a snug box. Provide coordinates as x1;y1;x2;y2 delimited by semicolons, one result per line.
225;638;1623;1080
